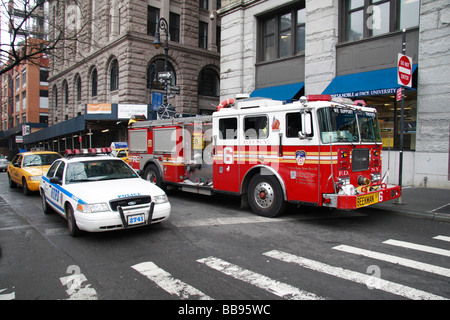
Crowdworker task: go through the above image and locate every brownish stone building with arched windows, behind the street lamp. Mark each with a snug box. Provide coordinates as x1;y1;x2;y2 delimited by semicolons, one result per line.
27;0;220;149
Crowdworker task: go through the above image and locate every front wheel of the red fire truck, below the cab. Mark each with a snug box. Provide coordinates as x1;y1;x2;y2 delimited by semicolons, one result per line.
248;174;286;218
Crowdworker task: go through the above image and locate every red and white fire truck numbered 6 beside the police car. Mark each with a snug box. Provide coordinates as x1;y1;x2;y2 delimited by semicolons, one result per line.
128;96;401;217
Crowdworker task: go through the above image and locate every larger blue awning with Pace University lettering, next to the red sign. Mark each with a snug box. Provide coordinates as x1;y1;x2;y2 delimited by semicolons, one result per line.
322;64;417;98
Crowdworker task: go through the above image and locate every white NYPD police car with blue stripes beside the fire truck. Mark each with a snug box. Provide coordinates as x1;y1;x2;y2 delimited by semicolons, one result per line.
39;148;171;236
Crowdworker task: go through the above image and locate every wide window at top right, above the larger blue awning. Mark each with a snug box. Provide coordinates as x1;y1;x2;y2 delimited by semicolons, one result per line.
340;0;420;42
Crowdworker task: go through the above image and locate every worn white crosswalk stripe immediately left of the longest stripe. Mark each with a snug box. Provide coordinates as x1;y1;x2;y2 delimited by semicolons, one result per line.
197;257;323;300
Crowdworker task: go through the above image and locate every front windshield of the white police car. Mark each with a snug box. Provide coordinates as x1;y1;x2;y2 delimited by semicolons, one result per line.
66;159;138;183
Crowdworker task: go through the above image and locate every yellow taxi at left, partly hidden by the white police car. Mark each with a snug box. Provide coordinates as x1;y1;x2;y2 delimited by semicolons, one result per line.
7;151;61;195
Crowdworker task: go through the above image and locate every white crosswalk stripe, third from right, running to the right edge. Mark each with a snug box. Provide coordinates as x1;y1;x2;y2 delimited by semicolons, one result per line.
332;245;450;278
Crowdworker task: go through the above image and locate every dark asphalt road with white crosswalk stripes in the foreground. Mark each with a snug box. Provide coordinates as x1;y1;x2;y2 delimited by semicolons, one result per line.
0;173;450;308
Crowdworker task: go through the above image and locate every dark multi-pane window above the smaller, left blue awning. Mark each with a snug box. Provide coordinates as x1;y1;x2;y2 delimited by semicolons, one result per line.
258;1;306;61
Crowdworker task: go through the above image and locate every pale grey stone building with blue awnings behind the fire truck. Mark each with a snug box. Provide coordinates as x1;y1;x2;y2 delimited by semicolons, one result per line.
220;0;450;188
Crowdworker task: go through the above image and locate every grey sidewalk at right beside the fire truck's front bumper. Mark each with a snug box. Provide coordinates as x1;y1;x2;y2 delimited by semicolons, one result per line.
372;187;450;222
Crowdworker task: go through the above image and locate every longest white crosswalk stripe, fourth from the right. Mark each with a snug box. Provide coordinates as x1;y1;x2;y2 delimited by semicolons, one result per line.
263;250;447;300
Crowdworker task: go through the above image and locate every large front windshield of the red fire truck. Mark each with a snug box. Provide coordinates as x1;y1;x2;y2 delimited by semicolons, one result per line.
318;107;381;143
